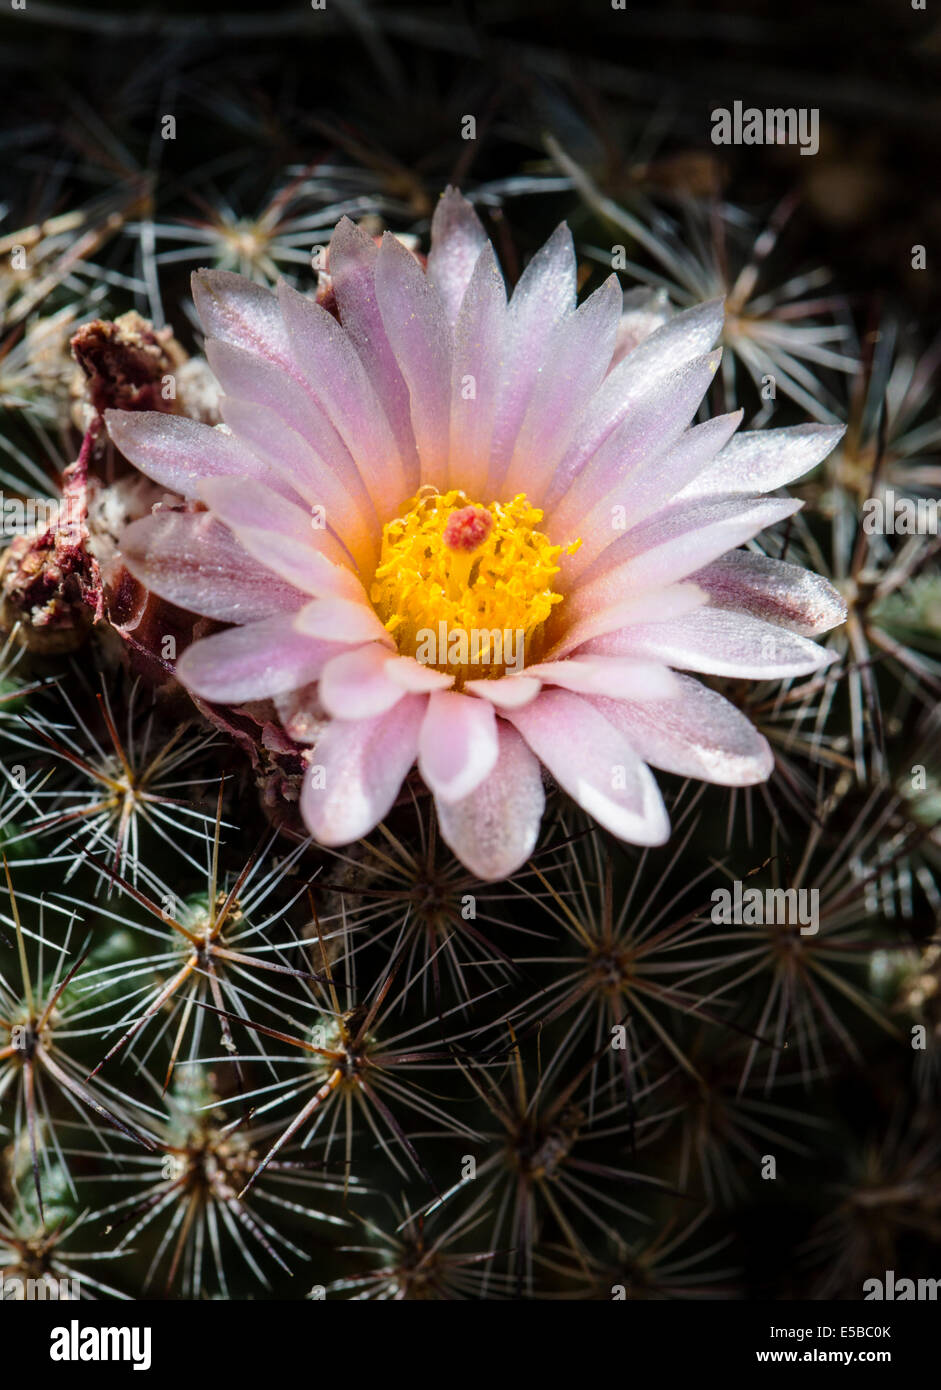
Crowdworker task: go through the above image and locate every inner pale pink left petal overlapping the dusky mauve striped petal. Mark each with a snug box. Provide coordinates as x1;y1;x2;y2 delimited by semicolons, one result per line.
199;478;354;578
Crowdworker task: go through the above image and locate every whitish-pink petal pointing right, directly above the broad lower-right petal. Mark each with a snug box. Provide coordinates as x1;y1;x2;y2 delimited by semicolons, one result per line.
589;607;837;678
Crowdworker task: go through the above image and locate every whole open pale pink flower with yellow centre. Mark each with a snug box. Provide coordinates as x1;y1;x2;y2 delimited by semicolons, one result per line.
108;189;845;878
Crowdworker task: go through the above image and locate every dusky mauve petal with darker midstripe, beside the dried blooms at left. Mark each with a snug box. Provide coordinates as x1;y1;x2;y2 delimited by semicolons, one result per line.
121;512;307;623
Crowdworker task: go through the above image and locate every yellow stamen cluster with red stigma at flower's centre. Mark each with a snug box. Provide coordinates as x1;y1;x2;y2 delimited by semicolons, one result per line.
370;488;581;688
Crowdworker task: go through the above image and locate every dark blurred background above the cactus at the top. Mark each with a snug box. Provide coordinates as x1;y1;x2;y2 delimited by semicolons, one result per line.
0;0;941;316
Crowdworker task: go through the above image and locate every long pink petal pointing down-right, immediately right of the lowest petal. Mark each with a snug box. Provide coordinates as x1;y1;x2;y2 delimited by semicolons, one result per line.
505;689;670;845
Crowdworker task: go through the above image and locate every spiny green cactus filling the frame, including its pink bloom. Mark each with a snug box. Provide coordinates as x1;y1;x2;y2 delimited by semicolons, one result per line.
0;7;941;1301
